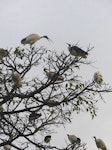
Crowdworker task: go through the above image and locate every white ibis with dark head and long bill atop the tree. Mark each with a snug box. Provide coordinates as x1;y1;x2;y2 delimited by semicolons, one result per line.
21;34;51;46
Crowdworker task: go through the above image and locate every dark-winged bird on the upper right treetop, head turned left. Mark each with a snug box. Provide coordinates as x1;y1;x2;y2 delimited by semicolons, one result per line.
66;43;88;58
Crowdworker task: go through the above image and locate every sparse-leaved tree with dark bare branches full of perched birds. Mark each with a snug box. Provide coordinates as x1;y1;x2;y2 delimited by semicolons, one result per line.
0;47;111;150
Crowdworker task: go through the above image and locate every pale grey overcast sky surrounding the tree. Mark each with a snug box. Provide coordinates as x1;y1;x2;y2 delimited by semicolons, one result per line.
0;0;112;150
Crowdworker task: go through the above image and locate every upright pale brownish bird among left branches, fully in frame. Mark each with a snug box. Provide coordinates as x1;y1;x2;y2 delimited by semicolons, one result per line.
12;71;22;87
